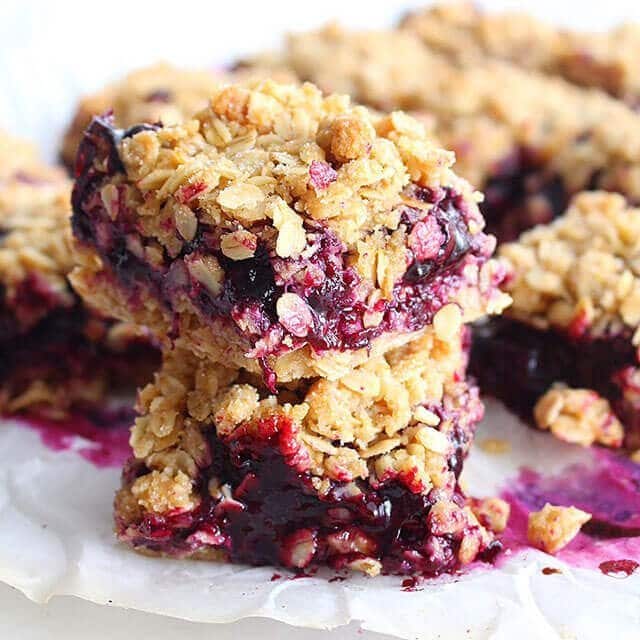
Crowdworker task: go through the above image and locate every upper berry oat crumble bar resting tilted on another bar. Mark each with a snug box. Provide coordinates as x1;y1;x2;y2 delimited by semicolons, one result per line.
72;81;509;388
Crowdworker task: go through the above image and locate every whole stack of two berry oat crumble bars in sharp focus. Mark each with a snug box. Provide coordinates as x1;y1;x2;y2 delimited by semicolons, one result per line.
72;81;509;575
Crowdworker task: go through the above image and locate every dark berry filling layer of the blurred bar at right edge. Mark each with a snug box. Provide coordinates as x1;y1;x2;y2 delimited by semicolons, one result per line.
470;318;640;446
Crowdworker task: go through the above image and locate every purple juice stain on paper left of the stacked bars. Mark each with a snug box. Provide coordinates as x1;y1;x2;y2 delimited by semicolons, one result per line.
16;407;134;468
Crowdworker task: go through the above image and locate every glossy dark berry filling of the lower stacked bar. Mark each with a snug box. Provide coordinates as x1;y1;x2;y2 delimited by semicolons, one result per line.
116;382;500;575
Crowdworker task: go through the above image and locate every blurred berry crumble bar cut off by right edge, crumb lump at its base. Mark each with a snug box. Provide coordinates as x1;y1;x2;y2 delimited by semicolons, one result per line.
474;192;640;448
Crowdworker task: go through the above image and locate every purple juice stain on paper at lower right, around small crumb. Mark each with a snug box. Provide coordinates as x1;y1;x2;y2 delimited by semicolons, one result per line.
501;449;640;577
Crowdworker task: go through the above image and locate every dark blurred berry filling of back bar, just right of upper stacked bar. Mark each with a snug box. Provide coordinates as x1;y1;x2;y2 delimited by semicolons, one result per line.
480;147;571;242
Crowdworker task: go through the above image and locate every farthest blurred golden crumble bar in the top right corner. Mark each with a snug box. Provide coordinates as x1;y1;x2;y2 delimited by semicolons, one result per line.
400;2;640;108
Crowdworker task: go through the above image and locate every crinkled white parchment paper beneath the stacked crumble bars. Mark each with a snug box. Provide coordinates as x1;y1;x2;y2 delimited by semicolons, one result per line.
0;406;640;640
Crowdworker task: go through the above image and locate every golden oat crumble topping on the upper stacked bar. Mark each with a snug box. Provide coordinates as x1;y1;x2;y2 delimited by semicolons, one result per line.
114;82;482;249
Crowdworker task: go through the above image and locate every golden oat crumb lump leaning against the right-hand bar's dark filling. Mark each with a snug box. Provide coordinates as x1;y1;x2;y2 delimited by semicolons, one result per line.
533;386;624;447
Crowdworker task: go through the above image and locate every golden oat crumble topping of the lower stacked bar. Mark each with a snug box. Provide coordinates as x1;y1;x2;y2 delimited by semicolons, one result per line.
131;332;473;510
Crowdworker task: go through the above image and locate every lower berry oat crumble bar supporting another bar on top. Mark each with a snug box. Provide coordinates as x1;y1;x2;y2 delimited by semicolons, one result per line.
115;333;507;575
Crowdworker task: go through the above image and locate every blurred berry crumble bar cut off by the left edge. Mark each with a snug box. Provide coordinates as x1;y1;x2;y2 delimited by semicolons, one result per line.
0;133;155;417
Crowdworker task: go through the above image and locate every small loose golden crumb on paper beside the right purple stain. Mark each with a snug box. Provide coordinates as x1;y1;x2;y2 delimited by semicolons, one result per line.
527;502;591;553
